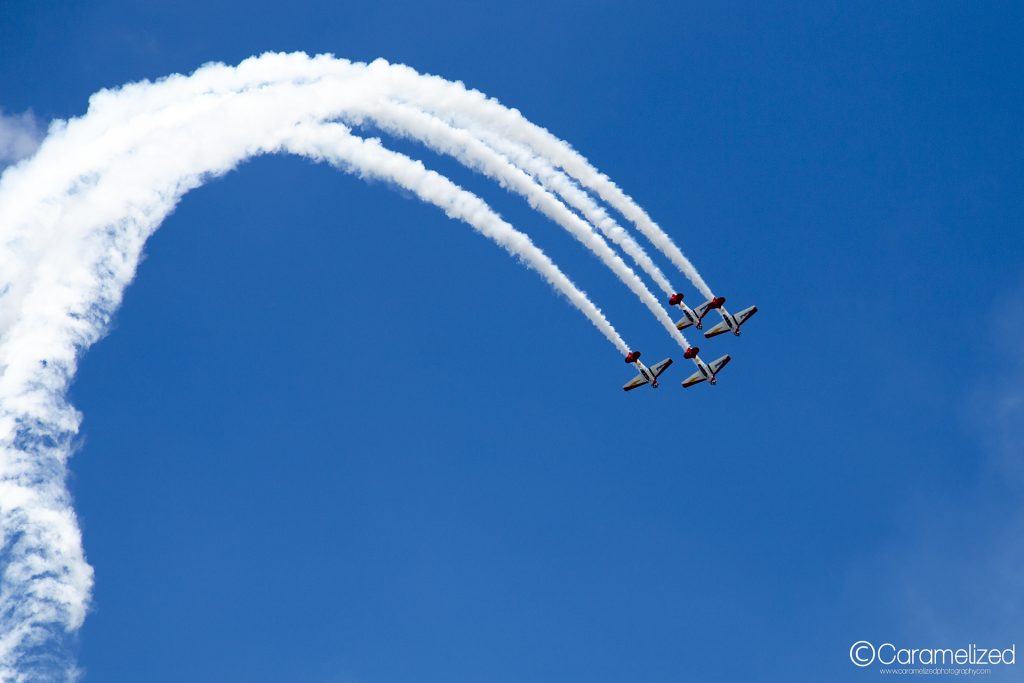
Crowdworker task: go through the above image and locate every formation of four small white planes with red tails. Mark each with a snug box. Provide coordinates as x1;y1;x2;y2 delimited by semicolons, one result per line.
623;292;758;391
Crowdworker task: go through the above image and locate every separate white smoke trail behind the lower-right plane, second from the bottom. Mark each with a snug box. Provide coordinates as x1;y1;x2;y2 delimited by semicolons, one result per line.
331;100;689;349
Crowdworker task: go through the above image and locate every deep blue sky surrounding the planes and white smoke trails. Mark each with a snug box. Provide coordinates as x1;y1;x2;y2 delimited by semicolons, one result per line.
0;0;1024;683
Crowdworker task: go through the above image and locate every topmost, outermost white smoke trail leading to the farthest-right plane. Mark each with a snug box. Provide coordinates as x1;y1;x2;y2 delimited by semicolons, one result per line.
369;59;713;298
